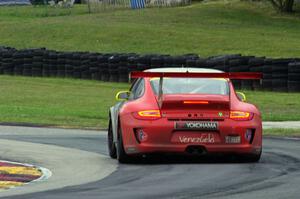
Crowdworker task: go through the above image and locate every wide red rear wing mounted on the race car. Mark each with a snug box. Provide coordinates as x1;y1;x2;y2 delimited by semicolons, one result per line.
130;71;262;108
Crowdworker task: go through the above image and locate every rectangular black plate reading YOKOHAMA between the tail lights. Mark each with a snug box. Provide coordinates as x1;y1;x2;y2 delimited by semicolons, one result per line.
174;121;219;131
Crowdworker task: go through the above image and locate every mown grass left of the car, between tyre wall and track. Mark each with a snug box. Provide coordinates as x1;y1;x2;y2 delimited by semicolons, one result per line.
0;76;128;128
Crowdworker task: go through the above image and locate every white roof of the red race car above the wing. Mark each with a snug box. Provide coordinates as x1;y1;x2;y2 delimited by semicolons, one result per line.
145;68;224;73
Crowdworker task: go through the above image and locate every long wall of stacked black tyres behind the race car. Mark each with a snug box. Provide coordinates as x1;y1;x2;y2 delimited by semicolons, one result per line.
0;47;300;92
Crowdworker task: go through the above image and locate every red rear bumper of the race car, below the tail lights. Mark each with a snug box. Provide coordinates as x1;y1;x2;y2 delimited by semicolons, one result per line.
121;114;262;155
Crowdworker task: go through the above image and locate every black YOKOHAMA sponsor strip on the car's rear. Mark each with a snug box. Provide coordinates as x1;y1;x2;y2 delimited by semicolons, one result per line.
175;122;218;131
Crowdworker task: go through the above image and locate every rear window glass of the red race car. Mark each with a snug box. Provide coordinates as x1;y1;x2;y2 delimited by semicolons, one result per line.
150;78;229;95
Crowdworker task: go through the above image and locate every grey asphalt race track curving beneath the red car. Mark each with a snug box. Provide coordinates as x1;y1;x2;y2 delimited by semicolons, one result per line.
0;127;300;199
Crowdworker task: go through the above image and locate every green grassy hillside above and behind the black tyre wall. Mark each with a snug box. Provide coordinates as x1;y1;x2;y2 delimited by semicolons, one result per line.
0;0;300;57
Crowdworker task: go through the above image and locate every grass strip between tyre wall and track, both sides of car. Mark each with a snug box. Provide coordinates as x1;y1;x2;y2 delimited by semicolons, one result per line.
0;76;300;128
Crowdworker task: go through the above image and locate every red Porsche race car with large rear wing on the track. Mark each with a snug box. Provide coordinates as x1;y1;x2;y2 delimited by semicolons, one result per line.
108;68;262;163
